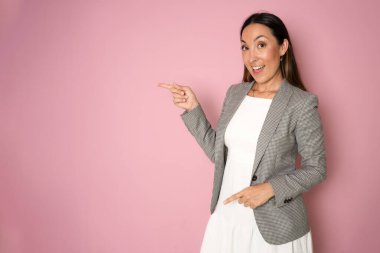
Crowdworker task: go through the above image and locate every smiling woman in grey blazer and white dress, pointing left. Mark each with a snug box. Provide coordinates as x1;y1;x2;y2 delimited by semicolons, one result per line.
159;13;326;253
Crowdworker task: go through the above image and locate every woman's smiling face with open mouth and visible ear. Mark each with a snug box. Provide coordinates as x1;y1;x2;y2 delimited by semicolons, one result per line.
241;24;288;85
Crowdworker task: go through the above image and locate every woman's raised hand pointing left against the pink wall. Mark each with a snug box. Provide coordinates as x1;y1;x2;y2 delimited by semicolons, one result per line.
158;83;199;111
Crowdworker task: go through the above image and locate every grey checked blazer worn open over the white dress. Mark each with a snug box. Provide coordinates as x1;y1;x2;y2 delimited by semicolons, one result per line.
181;79;326;244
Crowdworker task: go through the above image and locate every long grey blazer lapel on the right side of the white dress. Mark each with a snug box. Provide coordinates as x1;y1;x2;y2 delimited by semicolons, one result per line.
251;79;293;177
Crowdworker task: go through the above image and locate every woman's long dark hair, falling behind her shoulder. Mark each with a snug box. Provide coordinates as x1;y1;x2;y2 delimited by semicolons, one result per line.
240;12;306;91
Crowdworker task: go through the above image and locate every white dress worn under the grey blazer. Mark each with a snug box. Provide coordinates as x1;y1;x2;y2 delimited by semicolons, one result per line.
200;95;313;253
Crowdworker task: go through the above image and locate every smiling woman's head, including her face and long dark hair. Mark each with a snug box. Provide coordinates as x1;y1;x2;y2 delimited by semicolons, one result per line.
240;13;306;95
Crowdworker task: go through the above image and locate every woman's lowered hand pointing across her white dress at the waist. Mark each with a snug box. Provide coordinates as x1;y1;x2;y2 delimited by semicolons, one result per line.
223;183;274;208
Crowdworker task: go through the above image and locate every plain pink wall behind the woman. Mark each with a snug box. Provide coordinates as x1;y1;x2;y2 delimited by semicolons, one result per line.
0;0;380;253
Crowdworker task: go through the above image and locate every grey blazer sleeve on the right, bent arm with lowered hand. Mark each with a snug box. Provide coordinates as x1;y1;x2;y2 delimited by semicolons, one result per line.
268;94;326;207
